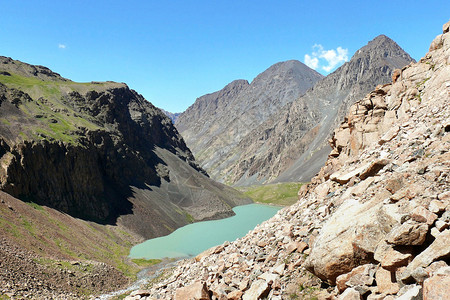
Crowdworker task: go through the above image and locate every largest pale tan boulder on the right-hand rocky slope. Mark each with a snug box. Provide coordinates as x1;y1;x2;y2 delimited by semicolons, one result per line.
304;199;397;284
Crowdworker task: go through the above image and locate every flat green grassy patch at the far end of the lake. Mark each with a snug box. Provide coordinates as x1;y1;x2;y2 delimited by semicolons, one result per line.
236;182;303;206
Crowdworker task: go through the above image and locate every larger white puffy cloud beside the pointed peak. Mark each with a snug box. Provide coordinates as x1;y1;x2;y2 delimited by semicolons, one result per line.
305;44;348;73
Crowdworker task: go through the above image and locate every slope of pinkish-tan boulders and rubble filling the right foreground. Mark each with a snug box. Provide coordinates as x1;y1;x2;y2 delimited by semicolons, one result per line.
121;22;450;300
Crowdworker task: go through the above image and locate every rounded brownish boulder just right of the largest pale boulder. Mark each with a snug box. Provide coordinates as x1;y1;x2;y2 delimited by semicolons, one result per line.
386;221;428;245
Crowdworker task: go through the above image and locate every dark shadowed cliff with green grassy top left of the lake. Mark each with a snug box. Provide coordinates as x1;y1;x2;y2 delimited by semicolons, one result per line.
0;57;249;237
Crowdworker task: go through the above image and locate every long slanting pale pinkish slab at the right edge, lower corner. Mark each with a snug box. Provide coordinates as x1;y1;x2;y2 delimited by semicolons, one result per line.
402;229;450;282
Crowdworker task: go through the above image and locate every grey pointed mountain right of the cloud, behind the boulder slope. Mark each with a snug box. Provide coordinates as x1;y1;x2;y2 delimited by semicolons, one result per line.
225;35;414;185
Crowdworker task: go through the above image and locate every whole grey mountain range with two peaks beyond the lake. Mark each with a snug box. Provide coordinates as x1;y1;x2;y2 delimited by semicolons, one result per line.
175;35;413;185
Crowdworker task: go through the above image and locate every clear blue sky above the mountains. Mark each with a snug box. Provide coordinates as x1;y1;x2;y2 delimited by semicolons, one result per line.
0;0;450;112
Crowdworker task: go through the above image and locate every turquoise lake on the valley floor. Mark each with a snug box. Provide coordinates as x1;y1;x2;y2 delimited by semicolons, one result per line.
130;204;281;259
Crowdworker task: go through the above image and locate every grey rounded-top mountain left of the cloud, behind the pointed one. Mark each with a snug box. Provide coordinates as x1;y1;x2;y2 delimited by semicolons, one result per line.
175;60;323;180
